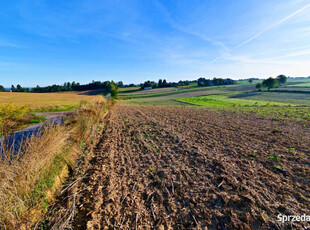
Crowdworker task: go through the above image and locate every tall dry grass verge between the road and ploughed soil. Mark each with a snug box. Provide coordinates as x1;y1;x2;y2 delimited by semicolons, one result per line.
0;97;110;229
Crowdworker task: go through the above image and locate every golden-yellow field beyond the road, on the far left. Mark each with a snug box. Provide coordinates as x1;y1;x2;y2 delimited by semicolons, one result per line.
0;92;101;112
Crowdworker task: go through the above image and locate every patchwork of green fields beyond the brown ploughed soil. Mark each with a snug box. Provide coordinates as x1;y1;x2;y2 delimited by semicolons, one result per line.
120;79;310;122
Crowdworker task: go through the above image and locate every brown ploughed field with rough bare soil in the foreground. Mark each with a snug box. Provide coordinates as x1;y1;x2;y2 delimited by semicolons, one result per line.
74;106;310;229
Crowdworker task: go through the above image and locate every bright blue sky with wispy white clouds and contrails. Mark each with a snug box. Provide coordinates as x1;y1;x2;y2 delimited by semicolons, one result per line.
0;0;310;86
